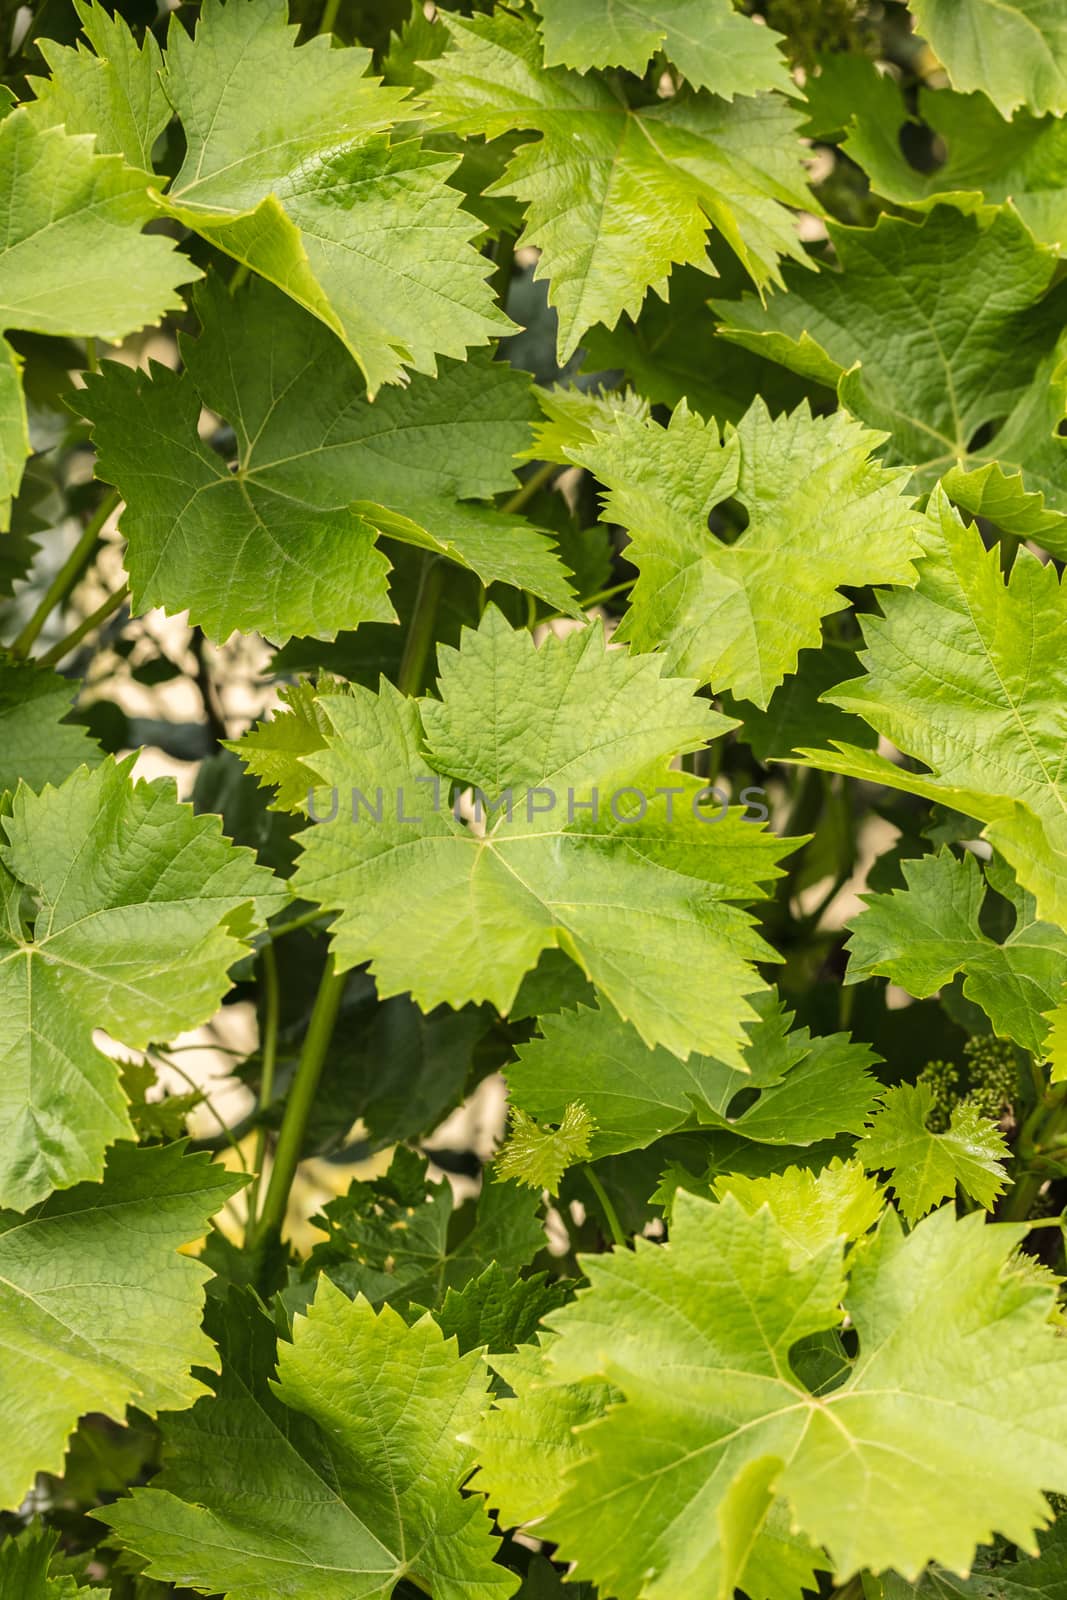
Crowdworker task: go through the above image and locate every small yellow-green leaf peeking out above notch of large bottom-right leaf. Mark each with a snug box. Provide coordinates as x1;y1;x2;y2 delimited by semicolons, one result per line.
713;1158;881;1264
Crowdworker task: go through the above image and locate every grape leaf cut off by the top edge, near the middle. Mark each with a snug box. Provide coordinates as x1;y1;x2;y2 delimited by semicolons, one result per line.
536;0;793;99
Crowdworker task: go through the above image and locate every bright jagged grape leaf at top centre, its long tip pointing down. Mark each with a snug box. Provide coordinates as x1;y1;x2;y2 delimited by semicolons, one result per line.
427;11;814;365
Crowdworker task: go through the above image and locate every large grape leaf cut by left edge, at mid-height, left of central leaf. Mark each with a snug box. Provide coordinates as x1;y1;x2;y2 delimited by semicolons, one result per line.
0;757;279;1210
